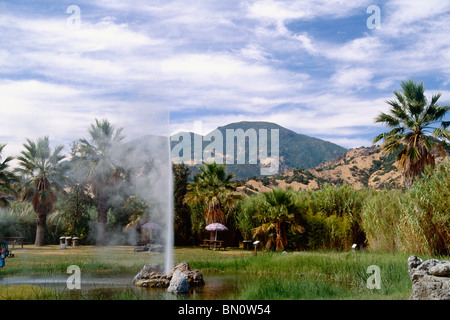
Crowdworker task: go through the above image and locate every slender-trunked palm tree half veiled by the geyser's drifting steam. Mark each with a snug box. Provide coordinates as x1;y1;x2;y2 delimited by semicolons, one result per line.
72;119;124;245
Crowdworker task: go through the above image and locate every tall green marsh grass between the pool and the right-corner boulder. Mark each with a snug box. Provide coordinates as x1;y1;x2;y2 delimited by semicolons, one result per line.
232;252;411;300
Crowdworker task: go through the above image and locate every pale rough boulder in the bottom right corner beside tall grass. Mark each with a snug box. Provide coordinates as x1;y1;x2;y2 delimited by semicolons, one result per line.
408;256;450;300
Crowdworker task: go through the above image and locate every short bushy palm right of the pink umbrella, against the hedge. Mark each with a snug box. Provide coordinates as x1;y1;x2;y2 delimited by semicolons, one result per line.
253;188;303;251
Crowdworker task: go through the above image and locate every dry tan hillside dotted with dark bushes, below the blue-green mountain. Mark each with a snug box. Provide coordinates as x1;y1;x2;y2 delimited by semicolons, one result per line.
239;146;443;194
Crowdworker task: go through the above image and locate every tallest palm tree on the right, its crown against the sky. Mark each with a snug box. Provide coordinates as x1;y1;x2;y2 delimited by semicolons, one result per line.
373;80;450;188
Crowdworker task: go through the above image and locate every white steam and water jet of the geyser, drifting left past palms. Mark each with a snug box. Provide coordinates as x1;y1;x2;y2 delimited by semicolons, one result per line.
72;127;173;272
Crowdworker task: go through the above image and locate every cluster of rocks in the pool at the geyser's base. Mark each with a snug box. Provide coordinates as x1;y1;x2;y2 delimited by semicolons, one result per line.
133;262;205;288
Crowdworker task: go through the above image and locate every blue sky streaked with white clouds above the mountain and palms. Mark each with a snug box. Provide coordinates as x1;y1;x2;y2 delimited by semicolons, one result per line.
0;0;450;160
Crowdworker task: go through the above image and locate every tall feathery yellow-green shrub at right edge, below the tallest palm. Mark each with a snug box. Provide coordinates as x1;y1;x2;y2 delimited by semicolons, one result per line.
361;161;450;255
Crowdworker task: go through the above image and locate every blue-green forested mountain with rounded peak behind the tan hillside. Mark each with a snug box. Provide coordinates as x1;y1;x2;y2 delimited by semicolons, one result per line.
171;121;347;180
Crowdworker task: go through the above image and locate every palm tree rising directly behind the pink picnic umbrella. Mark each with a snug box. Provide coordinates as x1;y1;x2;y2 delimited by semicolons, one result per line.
185;162;241;224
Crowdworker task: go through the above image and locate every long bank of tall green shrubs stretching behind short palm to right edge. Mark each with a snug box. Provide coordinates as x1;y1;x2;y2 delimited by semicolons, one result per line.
236;160;450;255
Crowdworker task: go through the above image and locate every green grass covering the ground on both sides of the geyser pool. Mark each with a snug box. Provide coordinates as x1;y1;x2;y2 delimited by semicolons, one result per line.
0;245;442;300
